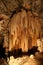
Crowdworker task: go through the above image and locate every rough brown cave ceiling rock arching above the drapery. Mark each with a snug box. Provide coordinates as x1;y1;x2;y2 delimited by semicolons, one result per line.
0;0;43;35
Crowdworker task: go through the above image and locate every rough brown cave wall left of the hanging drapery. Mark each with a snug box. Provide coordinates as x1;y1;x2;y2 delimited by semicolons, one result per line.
0;14;9;53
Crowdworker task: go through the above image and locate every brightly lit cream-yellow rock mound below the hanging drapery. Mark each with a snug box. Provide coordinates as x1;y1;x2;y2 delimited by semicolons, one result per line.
9;54;43;65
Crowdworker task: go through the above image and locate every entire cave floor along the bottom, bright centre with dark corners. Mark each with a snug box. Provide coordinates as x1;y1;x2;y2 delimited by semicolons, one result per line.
0;53;43;65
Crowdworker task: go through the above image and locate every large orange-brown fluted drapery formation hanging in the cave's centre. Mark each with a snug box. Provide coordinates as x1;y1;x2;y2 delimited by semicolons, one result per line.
9;9;41;52
